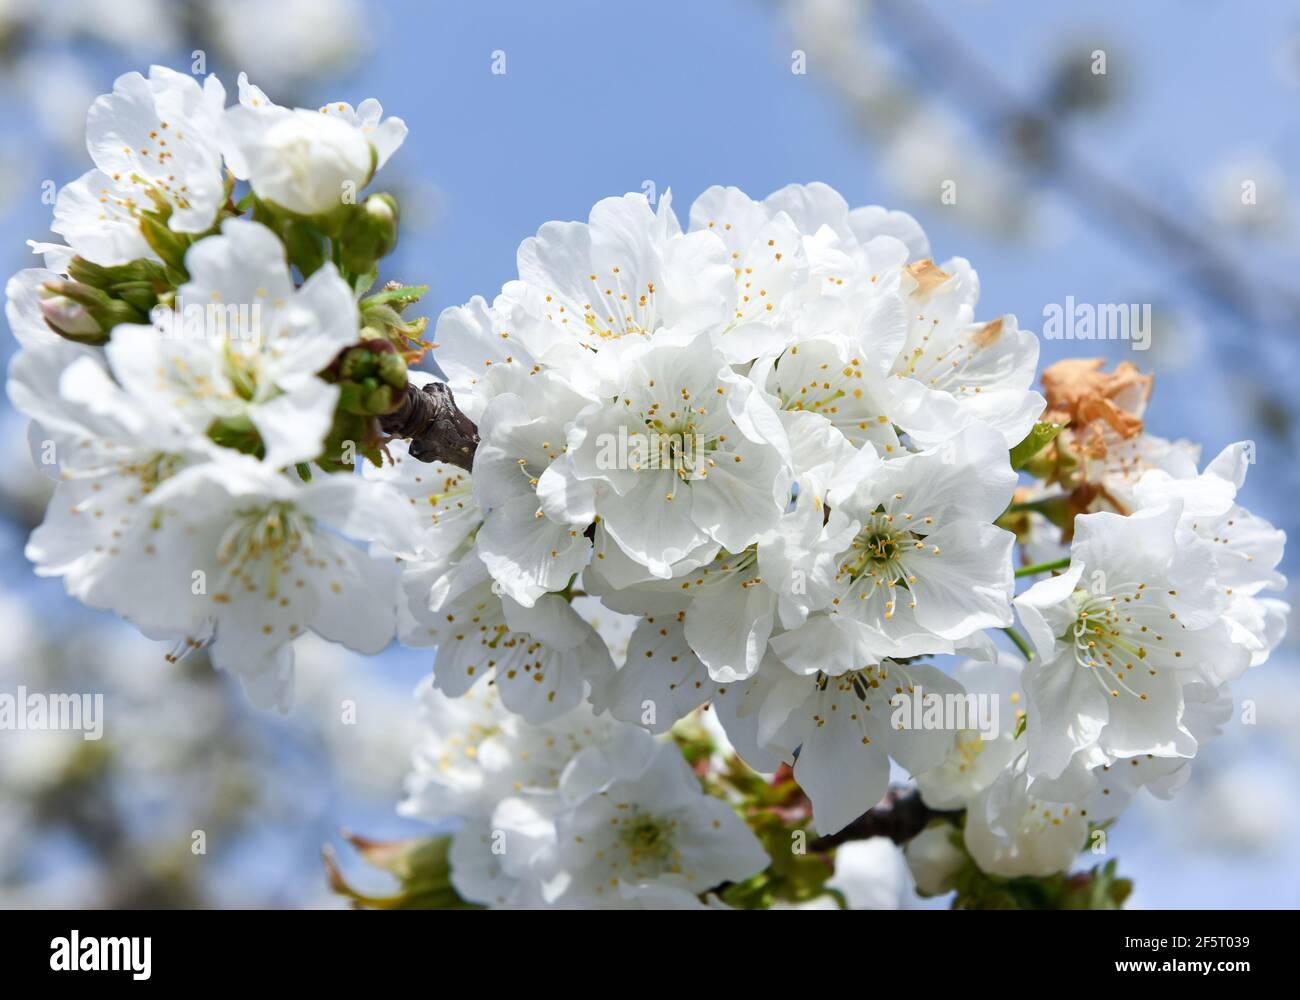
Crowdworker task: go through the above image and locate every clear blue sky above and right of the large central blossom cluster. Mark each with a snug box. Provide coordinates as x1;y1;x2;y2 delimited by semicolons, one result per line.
355;0;1300;551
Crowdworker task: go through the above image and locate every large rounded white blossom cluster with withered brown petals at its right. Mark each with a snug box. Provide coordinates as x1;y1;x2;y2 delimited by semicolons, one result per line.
379;185;1287;899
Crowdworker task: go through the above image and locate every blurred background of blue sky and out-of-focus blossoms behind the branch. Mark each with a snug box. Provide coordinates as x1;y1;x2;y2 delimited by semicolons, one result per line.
0;0;1300;906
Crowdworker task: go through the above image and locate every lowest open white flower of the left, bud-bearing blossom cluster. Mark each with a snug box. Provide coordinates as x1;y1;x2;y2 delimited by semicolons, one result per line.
129;455;410;707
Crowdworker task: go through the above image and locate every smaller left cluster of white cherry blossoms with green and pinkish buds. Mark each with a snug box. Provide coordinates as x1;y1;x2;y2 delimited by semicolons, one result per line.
5;66;423;705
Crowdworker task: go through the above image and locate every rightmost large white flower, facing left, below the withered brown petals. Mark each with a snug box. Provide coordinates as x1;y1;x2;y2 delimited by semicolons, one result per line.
1015;501;1249;779
